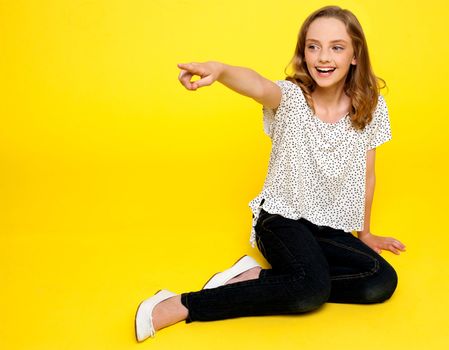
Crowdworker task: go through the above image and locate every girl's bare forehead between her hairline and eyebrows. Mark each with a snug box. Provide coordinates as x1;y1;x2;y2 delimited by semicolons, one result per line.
306;17;351;41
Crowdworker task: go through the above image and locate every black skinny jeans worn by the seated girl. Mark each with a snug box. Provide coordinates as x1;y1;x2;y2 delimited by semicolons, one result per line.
181;209;398;323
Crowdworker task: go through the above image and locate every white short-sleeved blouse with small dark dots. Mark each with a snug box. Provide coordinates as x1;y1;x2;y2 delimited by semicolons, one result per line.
249;80;391;247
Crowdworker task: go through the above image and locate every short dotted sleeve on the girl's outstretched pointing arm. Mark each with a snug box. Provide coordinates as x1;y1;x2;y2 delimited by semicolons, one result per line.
262;80;296;137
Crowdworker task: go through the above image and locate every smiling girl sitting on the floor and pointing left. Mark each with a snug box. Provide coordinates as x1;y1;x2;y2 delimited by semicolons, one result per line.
135;6;405;341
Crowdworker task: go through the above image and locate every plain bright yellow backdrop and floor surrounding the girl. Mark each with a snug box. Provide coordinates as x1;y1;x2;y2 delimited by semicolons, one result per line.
0;0;449;350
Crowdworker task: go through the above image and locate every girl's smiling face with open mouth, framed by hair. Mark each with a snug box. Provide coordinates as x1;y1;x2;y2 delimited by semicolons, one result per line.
304;17;356;88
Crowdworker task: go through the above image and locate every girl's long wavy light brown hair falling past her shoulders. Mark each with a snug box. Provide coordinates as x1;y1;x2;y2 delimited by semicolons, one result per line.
284;6;386;130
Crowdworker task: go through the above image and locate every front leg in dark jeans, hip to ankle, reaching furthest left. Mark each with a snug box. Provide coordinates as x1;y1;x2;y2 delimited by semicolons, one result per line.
181;212;331;323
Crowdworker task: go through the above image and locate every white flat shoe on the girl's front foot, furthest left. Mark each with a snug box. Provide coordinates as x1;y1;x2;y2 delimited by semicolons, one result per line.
135;289;177;342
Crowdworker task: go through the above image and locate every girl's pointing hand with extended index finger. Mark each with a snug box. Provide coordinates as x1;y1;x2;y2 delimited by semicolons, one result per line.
178;61;223;90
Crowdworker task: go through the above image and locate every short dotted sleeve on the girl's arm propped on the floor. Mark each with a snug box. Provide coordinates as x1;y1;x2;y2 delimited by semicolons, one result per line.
366;95;391;151
